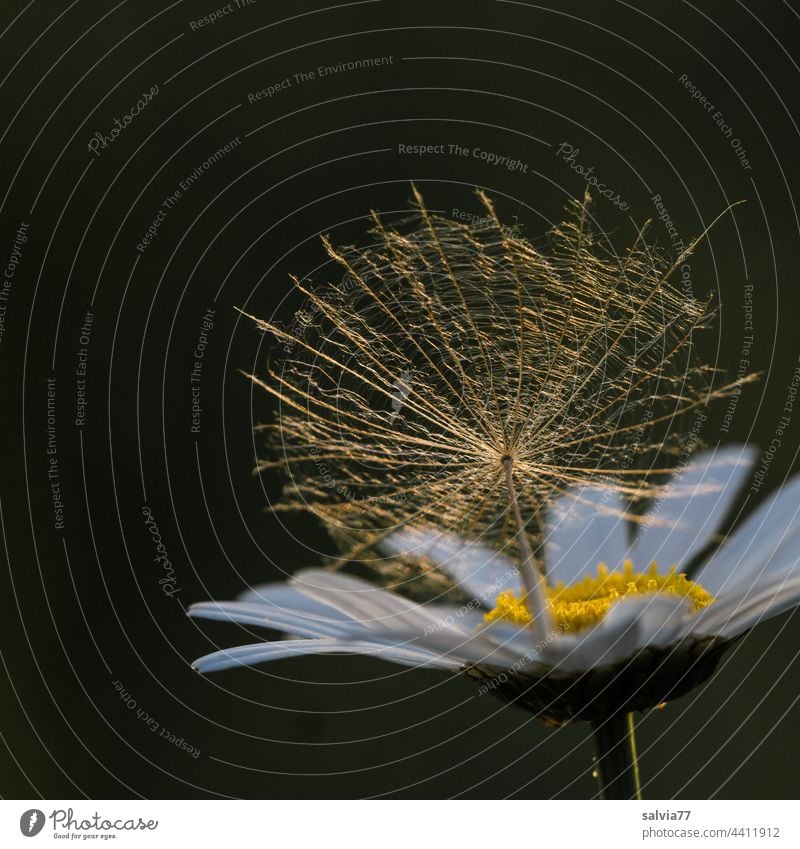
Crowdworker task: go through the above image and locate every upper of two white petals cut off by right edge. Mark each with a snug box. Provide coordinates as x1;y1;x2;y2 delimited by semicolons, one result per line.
696;476;800;596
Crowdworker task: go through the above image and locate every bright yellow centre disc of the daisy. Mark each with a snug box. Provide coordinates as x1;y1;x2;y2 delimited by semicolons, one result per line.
484;560;714;631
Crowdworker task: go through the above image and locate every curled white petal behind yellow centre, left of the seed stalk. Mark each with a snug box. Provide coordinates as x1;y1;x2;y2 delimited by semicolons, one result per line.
381;526;522;607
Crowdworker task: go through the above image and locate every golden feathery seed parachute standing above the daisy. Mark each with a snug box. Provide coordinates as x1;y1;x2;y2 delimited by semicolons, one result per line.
245;189;752;594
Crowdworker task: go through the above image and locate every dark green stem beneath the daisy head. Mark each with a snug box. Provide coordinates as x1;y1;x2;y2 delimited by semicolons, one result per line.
592;713;642;799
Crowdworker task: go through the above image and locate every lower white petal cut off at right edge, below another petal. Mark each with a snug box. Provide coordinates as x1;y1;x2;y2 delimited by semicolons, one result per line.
691;572;800;639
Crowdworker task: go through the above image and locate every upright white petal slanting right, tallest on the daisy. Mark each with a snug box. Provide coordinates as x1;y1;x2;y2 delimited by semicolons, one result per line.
628;445;756;569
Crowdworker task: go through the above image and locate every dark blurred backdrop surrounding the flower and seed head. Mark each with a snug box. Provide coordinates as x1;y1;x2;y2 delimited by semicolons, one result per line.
0;0;800;798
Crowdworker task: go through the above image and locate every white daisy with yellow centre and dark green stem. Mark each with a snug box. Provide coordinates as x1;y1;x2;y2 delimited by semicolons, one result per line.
190;446;800;798
